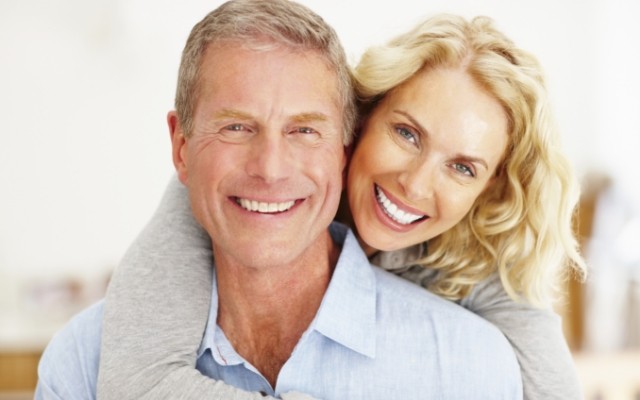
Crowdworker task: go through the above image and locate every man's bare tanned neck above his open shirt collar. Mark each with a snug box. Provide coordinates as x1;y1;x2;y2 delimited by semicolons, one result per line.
216;232;340;387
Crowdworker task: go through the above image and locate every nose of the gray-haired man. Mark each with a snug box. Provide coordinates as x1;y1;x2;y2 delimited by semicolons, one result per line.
247;132;292;183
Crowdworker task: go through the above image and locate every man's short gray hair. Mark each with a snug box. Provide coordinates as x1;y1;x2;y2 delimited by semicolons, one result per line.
175;0;356;145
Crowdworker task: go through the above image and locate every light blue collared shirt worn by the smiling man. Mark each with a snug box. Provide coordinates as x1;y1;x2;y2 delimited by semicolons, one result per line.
36;224;522;399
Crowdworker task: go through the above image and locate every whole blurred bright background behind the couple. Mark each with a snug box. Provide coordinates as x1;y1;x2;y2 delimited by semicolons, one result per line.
0;0;640;398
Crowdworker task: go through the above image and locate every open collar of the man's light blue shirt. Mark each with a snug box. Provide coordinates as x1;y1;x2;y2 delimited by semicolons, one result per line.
198;222;376;365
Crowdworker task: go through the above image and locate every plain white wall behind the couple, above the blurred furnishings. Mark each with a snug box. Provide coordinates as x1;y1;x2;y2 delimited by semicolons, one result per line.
0;0;640;282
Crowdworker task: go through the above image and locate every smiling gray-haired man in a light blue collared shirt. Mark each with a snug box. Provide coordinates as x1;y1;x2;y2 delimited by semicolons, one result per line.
36;0;521;399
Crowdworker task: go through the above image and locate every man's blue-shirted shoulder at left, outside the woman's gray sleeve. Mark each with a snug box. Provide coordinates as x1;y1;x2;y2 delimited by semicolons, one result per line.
35;301;104;399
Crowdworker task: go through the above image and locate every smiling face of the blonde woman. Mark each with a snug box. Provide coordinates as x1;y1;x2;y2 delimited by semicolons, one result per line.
348;68;508;250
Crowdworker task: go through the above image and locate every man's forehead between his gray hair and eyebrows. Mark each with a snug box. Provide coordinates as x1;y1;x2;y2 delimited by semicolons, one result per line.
198;41;343;124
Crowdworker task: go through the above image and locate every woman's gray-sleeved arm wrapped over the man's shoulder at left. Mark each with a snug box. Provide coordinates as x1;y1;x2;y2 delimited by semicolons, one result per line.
97;177;309;400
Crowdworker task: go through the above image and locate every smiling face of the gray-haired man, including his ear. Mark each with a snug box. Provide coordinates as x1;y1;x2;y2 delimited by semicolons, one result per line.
169;43;346;268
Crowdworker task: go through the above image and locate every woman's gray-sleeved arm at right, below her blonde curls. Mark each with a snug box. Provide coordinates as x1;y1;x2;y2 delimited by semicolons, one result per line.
390;262;583;400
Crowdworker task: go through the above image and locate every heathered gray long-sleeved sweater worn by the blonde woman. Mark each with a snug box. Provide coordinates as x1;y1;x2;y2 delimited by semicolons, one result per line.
97;178;583;400
